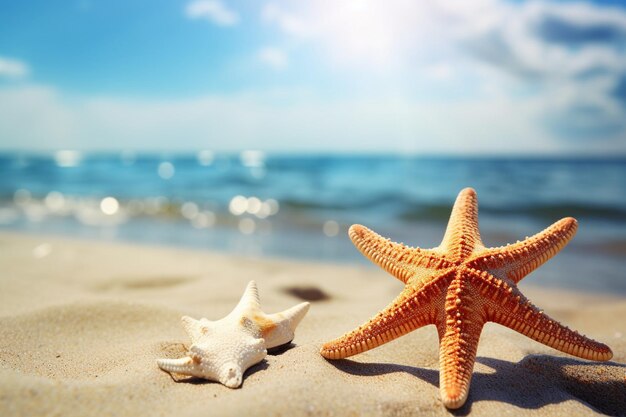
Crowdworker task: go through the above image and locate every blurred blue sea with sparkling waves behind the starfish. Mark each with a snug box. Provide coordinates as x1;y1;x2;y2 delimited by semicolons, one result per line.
0;151;626;294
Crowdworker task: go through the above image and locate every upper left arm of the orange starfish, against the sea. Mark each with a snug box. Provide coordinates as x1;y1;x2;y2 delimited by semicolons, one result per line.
348;224;445;283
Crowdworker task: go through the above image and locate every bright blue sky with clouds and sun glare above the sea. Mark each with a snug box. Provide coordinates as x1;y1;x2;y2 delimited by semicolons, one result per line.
0;0;626;154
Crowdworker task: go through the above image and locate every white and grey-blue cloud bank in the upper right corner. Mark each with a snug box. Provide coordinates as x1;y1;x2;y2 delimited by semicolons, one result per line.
454;2;626;139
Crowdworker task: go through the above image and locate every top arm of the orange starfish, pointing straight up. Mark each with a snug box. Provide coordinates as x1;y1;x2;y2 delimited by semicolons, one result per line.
439;188;483;261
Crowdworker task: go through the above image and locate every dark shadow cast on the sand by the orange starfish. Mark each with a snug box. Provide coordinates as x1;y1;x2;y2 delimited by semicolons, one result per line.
329;355;626;416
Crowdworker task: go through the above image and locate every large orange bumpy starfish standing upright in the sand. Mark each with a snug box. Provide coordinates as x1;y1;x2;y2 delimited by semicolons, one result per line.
320;188;613;409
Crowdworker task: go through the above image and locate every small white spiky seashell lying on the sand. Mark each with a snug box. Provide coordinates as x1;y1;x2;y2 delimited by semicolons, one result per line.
157;281;309;388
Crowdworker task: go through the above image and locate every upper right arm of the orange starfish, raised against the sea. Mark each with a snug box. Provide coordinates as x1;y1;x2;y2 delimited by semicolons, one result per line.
468;217;578;283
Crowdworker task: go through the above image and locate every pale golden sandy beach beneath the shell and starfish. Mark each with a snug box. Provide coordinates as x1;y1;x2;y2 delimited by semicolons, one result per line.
0;233;626;416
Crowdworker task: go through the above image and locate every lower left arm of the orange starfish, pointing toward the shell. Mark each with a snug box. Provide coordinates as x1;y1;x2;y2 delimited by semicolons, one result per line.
320;272;449;359
